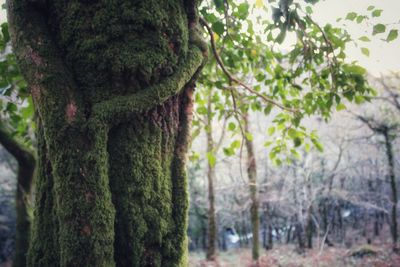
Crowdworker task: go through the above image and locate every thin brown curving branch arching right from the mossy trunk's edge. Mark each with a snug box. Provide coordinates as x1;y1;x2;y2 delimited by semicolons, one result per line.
199;18;298;113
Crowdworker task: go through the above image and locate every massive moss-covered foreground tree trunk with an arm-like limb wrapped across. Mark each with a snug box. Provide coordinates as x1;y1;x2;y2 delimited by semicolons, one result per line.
8;0;206;266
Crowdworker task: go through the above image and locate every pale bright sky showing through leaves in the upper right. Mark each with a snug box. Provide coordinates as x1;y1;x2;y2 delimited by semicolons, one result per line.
0;0;400;75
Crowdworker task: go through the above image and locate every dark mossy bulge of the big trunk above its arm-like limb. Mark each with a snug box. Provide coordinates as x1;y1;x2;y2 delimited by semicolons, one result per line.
45;0;188;103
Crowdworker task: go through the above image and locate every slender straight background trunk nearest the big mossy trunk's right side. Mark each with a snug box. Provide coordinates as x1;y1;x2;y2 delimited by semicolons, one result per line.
206;92;217;261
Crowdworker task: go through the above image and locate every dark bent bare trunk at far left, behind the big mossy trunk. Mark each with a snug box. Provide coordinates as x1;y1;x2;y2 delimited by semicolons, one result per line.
0;128;35;267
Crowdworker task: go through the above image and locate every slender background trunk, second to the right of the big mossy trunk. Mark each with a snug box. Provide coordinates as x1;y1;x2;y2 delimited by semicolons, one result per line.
243;114;260;261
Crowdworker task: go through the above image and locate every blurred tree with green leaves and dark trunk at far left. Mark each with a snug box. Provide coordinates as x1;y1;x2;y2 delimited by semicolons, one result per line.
0;23;35;267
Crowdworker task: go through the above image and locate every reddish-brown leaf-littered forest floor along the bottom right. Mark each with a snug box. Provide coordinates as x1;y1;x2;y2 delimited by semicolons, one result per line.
189;245;400;267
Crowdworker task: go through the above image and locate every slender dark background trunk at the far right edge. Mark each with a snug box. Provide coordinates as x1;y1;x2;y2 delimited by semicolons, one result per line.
383;131;398;250
